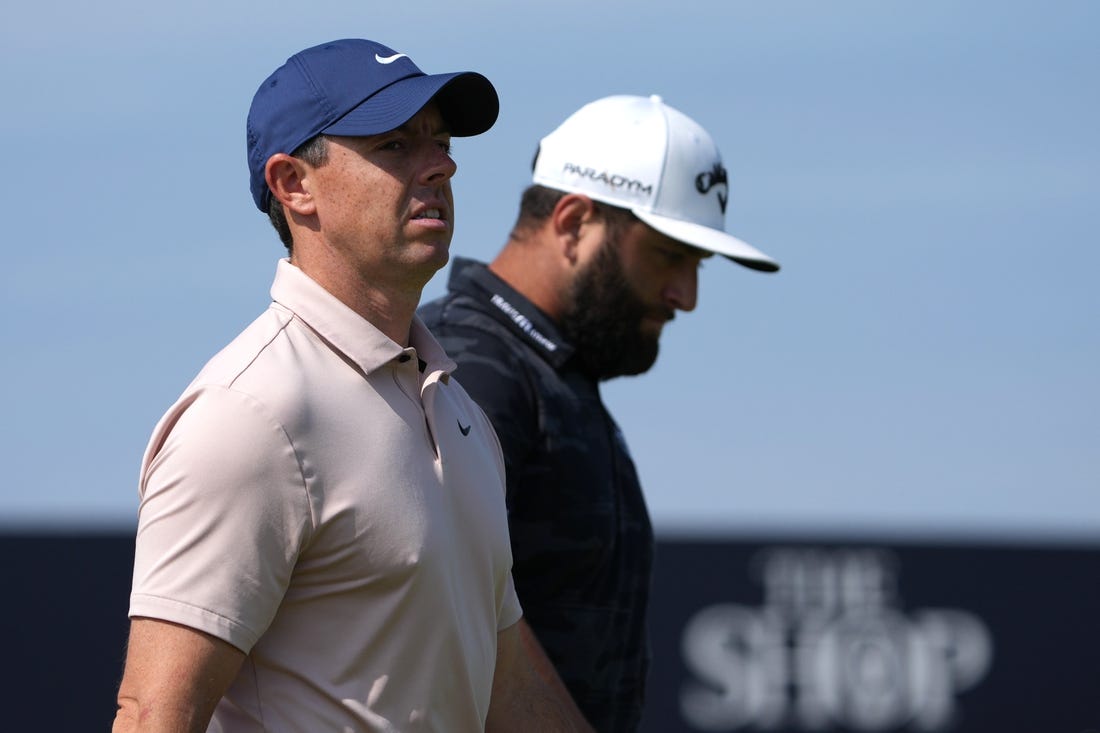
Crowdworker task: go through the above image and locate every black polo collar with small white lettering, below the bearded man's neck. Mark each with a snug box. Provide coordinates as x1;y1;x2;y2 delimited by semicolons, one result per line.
447;258;574;369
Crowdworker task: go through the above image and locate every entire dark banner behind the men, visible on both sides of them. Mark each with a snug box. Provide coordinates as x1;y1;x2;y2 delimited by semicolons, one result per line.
0;534;1100;733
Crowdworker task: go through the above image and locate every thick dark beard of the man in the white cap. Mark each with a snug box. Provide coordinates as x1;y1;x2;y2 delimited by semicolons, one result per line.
559;240;675;381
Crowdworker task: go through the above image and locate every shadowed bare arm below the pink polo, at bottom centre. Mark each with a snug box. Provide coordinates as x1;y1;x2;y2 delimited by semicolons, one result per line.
485;620;593;733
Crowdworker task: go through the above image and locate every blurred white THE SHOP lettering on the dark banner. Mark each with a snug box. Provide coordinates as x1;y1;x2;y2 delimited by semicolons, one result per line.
680;548;993;731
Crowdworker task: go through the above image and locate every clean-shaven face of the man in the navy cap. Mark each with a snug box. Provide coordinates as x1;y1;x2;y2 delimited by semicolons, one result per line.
312;102;457;285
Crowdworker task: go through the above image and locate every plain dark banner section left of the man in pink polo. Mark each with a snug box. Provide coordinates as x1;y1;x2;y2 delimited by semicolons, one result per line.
0;533;134;732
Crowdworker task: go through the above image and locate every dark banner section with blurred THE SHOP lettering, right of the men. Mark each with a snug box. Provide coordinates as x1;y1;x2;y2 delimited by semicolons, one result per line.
642;540;1100;733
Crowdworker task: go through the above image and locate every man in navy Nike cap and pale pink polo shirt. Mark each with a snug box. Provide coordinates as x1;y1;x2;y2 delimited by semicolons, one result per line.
114;40;585;732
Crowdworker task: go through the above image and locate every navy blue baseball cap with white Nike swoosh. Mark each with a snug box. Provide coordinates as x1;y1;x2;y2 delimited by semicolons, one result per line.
248;39;499;212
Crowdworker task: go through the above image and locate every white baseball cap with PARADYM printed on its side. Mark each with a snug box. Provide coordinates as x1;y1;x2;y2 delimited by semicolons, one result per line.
532;95;779;272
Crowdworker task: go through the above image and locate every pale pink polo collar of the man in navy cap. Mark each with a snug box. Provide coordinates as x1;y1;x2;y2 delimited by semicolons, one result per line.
271;258;455;382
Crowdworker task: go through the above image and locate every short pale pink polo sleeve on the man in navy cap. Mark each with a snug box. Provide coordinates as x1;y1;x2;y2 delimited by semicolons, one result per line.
130;386;312;653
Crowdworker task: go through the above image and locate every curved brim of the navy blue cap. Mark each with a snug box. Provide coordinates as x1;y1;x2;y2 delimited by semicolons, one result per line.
322;72;501;138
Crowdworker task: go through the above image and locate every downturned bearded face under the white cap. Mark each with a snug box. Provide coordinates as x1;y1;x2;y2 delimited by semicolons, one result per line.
561;217;711;380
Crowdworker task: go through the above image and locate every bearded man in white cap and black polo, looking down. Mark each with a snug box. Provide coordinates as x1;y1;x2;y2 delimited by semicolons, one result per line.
420;96;779;732
